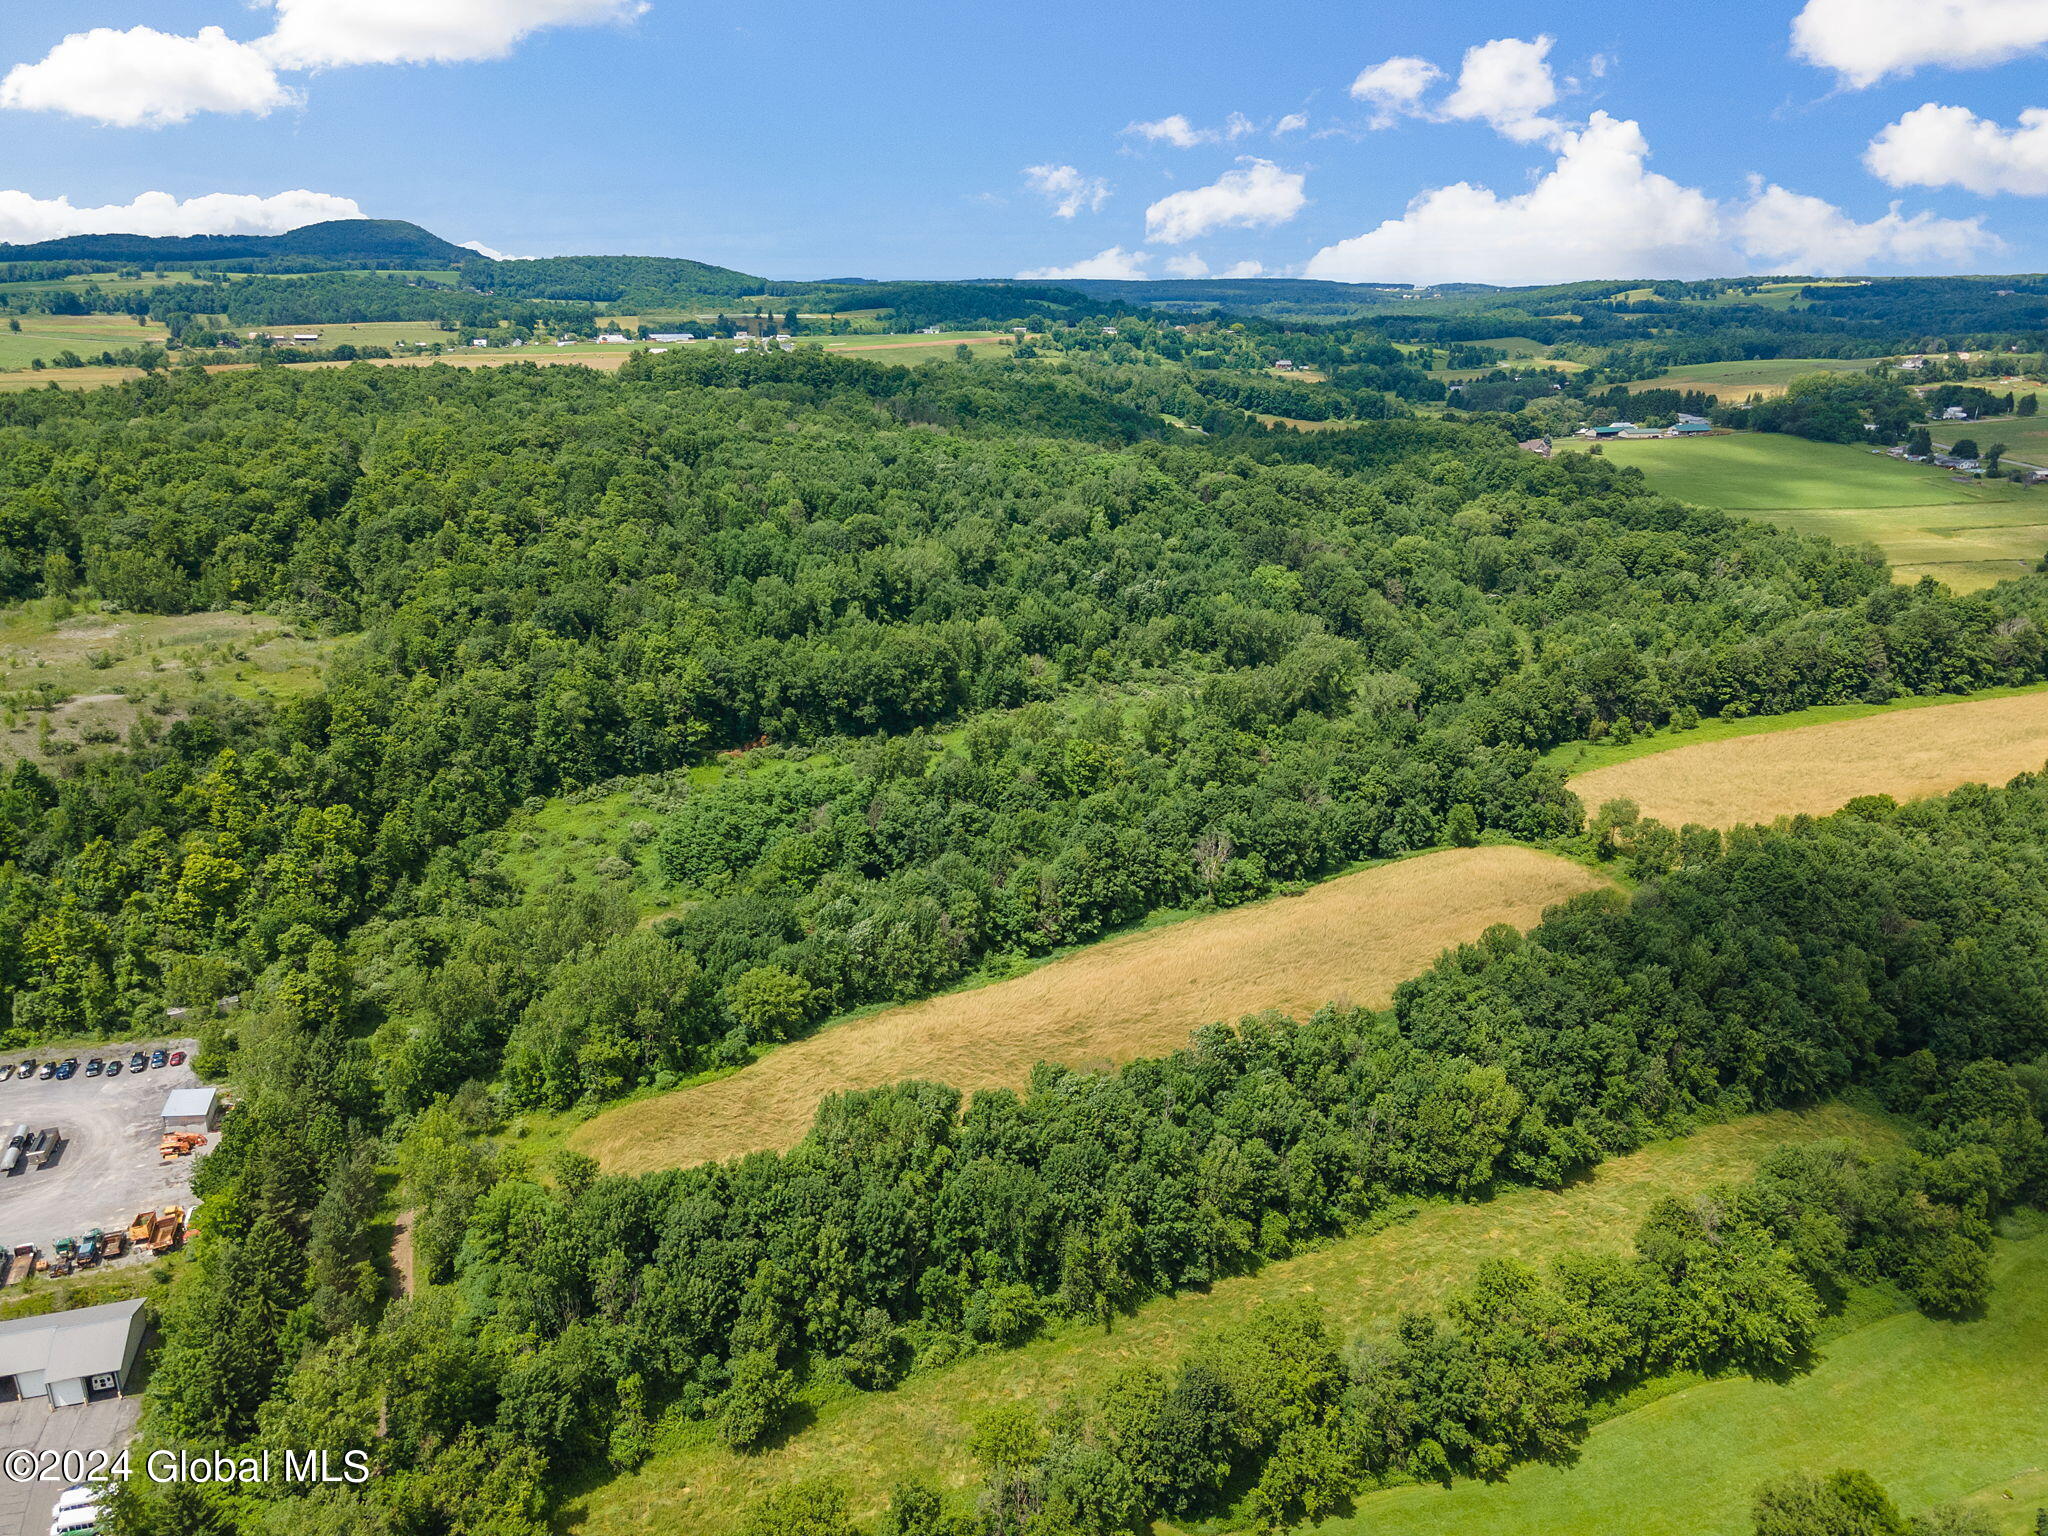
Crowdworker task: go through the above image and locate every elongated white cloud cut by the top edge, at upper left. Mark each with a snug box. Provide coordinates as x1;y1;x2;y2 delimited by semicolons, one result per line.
256;0;647;70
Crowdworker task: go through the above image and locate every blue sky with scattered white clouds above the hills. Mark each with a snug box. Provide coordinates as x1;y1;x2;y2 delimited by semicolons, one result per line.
0;0;2048;283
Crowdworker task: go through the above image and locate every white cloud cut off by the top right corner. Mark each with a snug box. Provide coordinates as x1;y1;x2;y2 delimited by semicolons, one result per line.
1792;0;2048;88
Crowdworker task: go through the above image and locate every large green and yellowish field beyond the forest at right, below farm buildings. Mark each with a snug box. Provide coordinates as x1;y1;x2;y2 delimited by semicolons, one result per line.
1604;426;2048;592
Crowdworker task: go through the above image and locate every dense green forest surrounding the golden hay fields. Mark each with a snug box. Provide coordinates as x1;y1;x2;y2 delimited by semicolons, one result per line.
0;352;2048;1536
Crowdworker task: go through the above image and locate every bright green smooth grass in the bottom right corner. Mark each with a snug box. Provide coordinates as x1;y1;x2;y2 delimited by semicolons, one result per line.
1317;1223;2048;1536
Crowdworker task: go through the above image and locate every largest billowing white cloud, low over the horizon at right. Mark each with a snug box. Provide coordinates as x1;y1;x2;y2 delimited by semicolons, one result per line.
1305;113;1997;285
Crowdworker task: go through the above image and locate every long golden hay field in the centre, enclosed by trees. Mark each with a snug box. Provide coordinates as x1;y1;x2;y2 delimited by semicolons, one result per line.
569;848;1602;1174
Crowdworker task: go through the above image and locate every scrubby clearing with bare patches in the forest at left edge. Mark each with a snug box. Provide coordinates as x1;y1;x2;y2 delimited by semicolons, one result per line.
0;598;336;762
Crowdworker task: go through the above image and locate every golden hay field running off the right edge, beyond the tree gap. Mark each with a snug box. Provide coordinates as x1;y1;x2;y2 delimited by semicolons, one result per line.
1571;692;2048;827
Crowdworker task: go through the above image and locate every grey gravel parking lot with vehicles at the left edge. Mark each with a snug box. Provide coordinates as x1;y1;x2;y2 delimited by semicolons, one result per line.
0;1040;213;1255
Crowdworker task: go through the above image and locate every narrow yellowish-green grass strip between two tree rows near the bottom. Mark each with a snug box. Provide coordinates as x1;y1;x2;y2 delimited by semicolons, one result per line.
565;1106;1896;1536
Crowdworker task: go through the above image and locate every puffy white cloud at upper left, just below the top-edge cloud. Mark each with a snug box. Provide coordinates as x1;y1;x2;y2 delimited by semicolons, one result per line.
0;27;297;127
